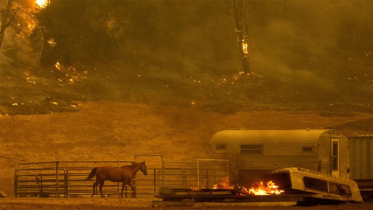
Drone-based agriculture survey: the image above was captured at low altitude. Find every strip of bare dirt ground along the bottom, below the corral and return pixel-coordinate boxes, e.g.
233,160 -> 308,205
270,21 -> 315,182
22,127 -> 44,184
0,198 -> 373,210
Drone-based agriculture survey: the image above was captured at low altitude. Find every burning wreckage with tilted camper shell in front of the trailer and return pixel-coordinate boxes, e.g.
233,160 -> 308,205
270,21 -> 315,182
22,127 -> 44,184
156,168 -> 363,204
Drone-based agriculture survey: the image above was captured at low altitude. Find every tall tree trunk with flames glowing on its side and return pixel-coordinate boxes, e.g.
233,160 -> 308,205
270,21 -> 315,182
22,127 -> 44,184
233,0 -> 250,72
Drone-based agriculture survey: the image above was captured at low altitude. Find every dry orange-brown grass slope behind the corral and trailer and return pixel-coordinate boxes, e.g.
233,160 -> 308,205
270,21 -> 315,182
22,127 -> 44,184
0,102 -> 373,196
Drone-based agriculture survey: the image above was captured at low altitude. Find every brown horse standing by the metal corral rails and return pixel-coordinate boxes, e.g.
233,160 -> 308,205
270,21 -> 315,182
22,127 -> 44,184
87,161 -> 148,198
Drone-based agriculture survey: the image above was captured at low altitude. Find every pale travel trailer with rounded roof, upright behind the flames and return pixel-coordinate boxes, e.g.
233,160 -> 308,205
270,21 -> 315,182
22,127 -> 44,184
208,129 -> 350,186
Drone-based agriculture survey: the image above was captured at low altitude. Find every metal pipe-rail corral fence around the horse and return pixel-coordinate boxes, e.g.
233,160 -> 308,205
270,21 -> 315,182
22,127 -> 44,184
14,157 -> 228,197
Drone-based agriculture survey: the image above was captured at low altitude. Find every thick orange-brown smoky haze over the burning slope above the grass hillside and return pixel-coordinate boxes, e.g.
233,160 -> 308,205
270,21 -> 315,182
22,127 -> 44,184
0,0 -> 373,113
